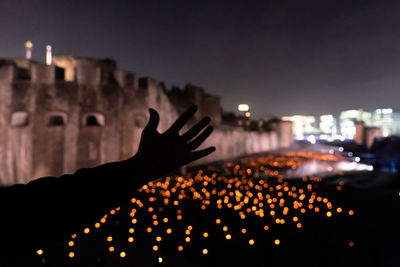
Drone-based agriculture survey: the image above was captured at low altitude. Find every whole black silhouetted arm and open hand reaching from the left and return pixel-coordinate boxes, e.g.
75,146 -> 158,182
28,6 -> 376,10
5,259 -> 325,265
0,106 -> 215,263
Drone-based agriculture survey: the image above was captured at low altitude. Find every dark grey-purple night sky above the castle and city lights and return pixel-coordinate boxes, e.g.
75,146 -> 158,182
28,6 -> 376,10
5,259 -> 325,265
0,0 -> 400,118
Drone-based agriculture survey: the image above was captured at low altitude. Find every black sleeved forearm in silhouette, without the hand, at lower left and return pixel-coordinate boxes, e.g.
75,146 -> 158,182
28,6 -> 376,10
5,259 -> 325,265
0,161 -> 148,261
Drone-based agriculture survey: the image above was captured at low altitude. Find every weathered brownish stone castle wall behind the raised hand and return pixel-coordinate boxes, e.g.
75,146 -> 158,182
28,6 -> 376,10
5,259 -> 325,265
0,57 -> 288,185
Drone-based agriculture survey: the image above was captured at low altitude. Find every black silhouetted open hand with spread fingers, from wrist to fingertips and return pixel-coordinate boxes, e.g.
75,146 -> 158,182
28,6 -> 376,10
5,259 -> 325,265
132,106 -> 215,178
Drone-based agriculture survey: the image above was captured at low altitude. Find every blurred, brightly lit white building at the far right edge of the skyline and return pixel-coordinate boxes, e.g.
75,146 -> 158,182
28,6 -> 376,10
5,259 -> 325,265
371,108 -> 400,137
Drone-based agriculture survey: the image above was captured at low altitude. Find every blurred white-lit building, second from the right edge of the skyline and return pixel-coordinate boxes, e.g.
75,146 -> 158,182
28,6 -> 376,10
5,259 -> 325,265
340,109 -> 371,139
